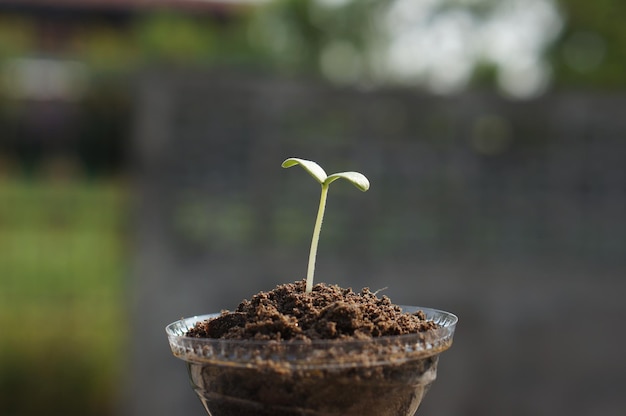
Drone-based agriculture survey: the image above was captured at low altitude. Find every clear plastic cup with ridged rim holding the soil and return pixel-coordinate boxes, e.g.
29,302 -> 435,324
166,306 -> 457,416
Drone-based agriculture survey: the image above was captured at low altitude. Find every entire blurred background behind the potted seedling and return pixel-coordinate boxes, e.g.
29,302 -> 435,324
0,0 -> 626,416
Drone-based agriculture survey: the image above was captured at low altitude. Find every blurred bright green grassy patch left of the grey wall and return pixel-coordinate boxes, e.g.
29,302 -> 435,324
0,178 -> 128,416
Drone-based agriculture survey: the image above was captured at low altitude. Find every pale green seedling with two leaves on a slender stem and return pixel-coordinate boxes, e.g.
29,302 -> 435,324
281,157 -> 370,293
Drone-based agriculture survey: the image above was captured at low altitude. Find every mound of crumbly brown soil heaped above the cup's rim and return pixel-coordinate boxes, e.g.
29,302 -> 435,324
187,281 -> 437,341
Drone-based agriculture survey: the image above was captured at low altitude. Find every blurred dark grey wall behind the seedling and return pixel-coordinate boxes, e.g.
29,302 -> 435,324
129,72 -> 626,415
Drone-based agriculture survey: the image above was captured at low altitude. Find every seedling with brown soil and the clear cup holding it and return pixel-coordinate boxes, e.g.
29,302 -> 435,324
166,158 -> 457,416
